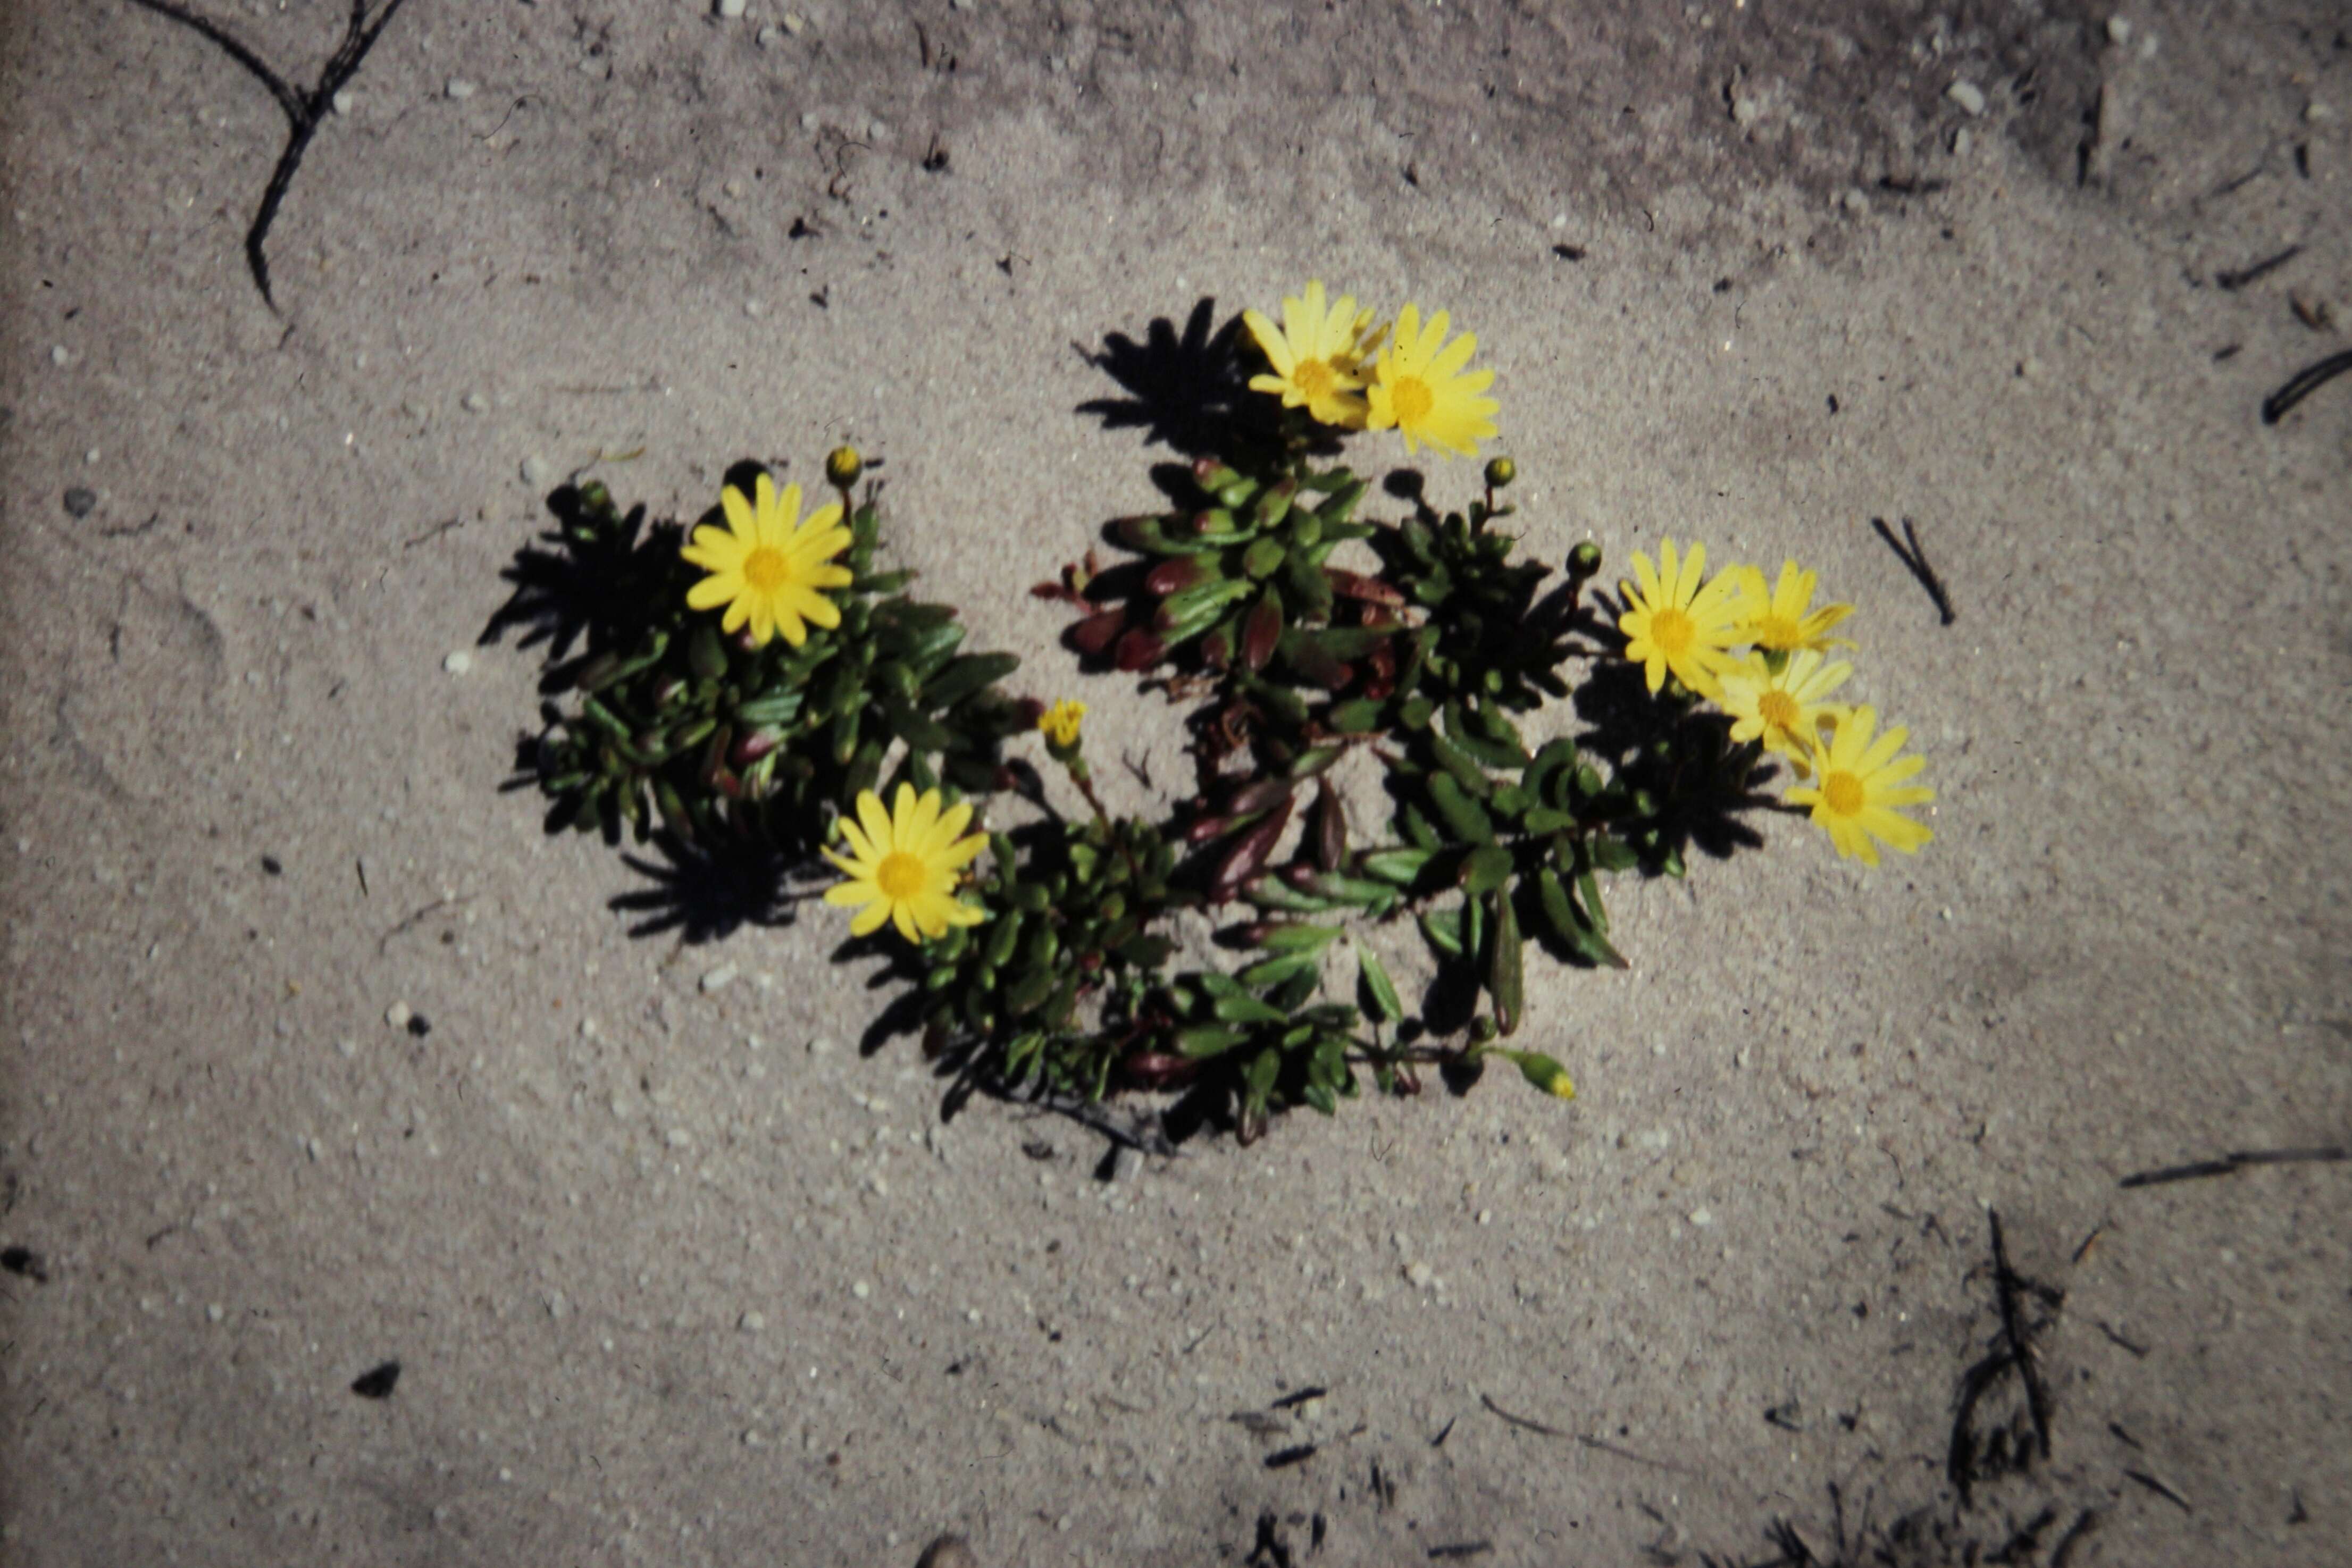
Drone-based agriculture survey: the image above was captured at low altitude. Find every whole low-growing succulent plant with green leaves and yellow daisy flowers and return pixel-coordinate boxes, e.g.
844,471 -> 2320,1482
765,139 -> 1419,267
505,284 -> 1931,1143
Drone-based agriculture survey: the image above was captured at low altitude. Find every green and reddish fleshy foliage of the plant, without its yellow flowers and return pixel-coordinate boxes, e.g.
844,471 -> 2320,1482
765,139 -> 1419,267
520,439 -> 1759,1140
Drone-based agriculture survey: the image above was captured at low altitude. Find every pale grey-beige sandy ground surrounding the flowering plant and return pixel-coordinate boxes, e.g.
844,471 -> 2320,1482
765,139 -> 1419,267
0,0 -> 2352,1568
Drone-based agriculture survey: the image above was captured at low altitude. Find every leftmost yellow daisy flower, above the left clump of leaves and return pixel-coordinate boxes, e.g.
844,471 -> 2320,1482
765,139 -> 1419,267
680,475 -> 849,649
